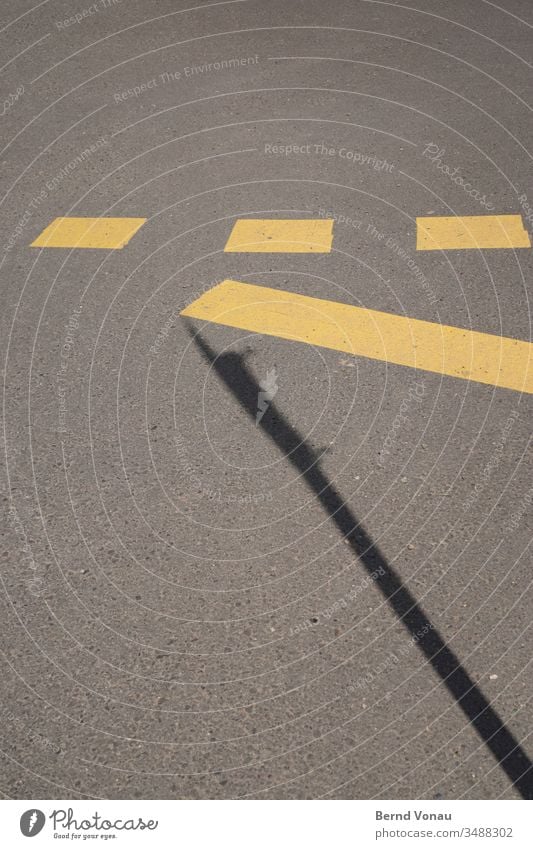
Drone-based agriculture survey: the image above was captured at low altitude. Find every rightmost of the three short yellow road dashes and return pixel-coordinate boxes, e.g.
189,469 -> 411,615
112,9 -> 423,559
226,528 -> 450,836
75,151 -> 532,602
416,215 -> 531,251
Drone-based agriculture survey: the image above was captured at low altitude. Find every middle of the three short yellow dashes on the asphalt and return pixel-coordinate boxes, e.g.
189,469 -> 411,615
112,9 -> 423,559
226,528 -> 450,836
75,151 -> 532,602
224,218 -> 333,254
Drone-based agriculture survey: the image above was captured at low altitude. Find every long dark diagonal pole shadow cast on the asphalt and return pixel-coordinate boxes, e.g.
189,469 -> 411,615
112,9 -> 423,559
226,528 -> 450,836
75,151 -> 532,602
184,319 -> 533,799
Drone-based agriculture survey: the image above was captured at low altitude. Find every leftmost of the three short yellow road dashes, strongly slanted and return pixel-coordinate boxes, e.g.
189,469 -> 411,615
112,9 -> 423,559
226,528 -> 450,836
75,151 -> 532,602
31,218 -> 146,250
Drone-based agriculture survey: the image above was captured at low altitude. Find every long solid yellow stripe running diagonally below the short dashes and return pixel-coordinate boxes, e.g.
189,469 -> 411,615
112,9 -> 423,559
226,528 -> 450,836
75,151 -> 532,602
181,280 -> 533,393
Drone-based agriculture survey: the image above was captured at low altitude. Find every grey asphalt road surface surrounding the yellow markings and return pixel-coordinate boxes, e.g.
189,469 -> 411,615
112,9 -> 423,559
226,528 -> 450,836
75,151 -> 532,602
0,0 -> 533,799
